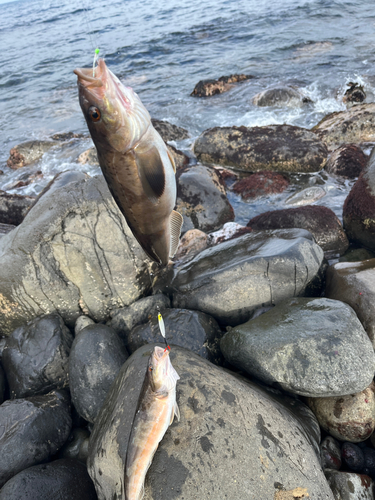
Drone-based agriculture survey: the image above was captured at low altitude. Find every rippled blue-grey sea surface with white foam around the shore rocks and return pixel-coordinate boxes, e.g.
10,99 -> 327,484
0,0 -> 375,223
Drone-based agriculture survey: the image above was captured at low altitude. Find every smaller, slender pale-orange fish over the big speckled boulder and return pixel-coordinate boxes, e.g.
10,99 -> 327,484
125,346 -> 180,500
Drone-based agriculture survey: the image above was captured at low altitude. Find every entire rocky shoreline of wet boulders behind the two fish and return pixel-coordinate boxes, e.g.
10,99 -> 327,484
0,94 -> 375,500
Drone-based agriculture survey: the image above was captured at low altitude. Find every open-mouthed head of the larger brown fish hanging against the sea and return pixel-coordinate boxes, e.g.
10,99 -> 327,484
74,59 -> 151,153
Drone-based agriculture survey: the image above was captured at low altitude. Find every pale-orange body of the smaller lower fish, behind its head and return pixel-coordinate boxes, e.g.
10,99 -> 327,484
125,395 -> 175,500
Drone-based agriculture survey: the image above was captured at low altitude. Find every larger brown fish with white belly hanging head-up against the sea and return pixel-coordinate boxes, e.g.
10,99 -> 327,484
74,59 -> 183,265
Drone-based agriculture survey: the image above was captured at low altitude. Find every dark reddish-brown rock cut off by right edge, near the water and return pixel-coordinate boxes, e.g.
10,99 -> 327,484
343,147 -> 375,250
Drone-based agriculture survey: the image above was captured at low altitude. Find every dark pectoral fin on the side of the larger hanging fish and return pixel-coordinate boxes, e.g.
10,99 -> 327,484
133,146 -> 165,203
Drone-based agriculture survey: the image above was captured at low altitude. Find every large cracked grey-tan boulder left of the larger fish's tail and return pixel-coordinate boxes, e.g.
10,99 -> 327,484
0,176 -> 150,335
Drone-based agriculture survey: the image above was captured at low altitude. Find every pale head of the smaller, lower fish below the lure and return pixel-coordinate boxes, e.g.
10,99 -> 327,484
148,346 -> 180,392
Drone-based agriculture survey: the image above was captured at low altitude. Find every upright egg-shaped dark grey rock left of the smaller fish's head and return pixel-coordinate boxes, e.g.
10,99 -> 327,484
69,324 -> 128,423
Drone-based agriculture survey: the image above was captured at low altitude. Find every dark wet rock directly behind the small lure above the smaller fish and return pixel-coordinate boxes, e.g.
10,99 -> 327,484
126,309 -> 223,364
